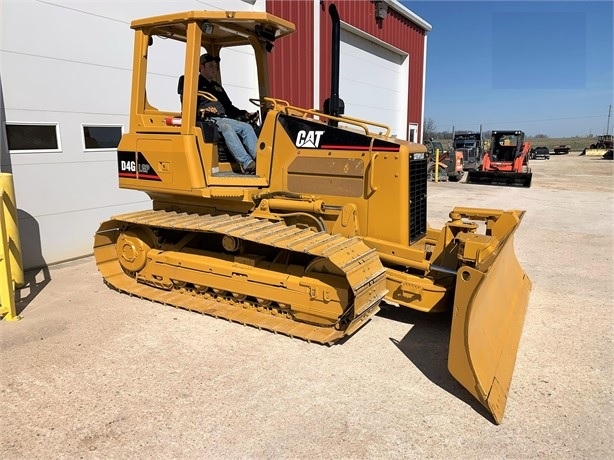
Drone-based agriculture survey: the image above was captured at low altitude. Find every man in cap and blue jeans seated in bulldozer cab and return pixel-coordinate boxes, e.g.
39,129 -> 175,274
178,53 -> 258,174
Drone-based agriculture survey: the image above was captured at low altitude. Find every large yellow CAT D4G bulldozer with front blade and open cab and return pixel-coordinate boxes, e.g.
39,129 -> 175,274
94,5 -> 531,423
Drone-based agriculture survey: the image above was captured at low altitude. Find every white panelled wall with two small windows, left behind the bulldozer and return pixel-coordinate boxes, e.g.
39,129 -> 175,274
0,0 -> 265,268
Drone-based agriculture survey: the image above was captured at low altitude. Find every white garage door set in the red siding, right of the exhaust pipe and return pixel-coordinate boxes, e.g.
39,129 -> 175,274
339,25 -> 409,139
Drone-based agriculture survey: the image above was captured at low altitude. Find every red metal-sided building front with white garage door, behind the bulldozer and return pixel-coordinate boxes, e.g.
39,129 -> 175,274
266,0 -> 431,141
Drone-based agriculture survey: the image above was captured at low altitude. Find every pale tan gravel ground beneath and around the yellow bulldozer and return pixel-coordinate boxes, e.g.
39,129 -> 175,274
0,152 -> 614,459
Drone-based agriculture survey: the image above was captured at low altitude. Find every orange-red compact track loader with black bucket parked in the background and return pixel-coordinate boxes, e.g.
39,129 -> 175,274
467,131 -> 533,187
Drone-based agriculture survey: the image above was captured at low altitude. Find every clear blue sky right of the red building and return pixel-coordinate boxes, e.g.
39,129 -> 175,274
400,0 -> 614,137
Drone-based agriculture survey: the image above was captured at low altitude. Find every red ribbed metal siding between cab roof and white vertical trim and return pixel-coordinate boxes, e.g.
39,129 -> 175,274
266,0 -> 313,107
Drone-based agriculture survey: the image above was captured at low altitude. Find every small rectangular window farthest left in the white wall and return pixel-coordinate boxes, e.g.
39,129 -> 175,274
6,122 -> 62,153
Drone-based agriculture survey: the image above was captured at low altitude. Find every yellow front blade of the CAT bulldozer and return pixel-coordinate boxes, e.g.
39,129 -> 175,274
448,214 -> 532,424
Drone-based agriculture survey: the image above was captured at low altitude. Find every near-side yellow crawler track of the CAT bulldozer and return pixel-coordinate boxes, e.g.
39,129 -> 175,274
94,210 -> 387,344
